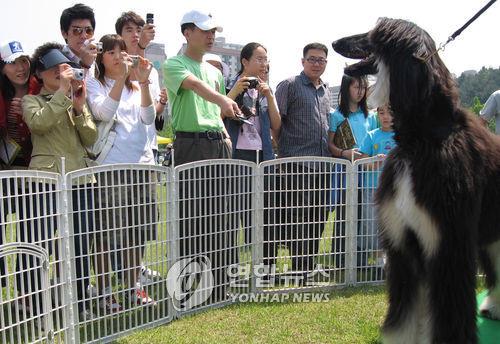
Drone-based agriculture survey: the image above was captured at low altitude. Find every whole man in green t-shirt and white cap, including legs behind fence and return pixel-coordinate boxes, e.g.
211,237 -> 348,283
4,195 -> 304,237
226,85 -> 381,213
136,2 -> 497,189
163,11 -> 240,310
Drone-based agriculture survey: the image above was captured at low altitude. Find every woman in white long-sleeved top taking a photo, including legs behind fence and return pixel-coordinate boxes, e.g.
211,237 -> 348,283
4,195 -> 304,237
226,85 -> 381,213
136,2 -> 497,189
87,35 -> 156,313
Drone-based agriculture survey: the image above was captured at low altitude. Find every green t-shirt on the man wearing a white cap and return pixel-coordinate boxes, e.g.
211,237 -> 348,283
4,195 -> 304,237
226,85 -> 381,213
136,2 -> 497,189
163,55 -> 226,132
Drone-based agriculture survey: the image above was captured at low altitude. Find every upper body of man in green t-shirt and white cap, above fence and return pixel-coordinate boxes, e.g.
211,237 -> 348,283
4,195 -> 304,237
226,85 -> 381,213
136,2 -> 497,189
163,11 -> 236,165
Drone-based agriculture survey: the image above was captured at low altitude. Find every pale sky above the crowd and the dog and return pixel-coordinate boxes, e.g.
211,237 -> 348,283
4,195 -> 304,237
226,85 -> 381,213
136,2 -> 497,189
0,0 -> 500,86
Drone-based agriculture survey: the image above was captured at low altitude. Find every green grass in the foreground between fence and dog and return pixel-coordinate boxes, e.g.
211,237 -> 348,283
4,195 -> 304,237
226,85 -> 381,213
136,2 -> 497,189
117,287 -> 386,344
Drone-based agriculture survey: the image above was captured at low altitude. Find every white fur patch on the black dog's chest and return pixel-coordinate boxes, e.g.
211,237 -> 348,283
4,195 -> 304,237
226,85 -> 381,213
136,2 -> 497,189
379,166 -> 441,258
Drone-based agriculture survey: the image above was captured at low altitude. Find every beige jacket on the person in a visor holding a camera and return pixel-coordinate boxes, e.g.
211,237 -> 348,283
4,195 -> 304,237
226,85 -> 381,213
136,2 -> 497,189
23,88 -> 97,173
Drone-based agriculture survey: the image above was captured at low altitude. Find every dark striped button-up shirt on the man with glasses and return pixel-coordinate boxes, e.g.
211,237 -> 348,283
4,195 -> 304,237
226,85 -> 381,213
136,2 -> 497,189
276,72 -> 331,158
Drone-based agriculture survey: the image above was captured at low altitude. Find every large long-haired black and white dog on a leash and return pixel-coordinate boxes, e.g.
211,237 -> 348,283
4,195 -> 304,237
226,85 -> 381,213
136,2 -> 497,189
332,18 -> 500,344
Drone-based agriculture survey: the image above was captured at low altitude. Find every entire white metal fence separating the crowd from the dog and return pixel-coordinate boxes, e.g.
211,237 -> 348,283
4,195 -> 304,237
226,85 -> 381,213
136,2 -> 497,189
0,157 -> 384,343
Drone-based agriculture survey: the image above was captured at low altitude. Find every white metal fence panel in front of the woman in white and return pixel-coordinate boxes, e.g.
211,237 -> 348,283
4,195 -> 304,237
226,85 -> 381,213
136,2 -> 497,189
65,164 -> 173,343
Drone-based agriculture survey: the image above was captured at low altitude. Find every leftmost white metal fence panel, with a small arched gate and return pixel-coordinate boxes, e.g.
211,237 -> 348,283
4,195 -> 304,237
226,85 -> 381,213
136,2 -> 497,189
0,171 -> 66,343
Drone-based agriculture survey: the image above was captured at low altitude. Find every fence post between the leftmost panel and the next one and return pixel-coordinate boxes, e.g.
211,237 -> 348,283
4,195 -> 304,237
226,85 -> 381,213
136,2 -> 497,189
59,157 -> 80,344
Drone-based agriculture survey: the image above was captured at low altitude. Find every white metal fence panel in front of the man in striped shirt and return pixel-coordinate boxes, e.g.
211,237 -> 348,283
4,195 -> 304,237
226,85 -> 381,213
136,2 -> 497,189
257,157 -> 349,291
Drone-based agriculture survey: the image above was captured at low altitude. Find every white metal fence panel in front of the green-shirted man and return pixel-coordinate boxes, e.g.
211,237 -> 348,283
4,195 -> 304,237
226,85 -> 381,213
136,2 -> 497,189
174,159 -> 257,315
